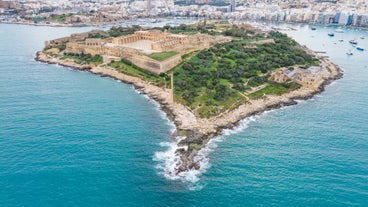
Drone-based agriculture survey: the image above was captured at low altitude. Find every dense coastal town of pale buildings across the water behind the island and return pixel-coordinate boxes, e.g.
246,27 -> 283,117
0,0 -> 368,27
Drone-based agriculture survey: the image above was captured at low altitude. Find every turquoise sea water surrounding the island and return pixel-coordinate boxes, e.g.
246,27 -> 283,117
0,24 -> 368,207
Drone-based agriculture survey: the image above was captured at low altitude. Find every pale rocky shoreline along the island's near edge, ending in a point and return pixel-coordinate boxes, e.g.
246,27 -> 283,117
35,51 -> 343,175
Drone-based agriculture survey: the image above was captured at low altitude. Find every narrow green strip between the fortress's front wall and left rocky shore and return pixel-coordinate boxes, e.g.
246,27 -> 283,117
108,59 -> 170,88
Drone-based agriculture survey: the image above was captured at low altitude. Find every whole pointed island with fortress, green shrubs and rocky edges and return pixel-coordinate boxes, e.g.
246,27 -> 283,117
36,21 -> 343,175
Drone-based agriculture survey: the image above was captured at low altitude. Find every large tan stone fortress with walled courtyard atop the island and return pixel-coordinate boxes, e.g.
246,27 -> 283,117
46,30 -> 231,74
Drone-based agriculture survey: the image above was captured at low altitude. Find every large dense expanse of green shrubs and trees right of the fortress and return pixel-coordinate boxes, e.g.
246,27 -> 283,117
174,28 -> 315,117
